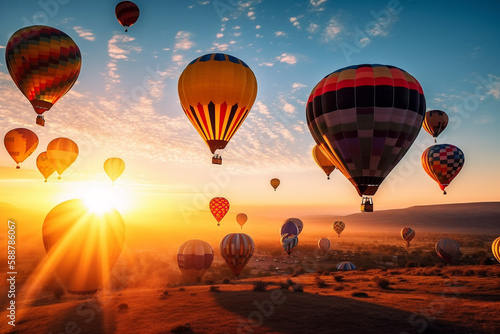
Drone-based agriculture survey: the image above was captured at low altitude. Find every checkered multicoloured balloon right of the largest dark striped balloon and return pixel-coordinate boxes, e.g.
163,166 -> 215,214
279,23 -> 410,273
421,144 -> 465,195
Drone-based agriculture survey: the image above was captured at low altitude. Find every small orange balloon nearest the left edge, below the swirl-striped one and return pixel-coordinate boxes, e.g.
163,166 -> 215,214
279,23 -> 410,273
3,128 -> 38,169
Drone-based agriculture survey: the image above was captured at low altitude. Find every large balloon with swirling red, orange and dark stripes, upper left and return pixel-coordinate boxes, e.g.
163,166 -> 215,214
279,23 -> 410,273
5,25 -> 82,126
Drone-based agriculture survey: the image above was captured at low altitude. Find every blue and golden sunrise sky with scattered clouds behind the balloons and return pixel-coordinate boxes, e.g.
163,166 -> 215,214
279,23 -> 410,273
0,0 -> 500,240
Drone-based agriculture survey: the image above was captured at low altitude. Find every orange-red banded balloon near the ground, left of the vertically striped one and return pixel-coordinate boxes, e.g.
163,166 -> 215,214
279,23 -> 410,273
177,239 -> 214,282
